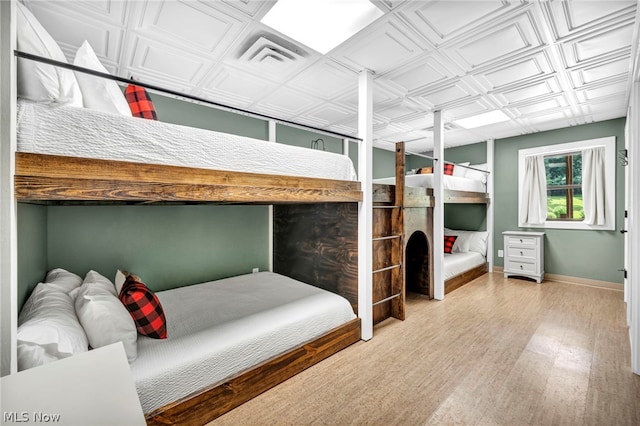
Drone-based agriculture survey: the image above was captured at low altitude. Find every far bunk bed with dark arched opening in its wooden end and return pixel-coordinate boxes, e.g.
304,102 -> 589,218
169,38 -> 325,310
374,142 -> 490,306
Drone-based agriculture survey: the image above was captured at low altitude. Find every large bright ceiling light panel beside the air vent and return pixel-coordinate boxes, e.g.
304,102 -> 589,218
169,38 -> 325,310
261,0 -> 383,55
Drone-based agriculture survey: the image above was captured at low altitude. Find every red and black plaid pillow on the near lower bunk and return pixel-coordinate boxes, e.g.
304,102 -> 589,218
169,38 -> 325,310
118,274 -> 167,339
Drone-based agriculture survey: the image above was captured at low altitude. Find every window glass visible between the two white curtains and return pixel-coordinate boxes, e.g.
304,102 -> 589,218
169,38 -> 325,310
544,152 -> 584,220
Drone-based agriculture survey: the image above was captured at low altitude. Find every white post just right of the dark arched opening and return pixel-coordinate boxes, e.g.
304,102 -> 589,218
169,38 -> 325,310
433,111 -> 444,300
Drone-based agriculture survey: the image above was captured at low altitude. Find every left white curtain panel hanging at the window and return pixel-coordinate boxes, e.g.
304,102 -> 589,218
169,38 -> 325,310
519,155 -> 547,225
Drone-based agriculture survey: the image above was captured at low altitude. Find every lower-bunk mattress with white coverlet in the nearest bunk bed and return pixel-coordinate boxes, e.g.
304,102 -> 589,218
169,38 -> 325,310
131,272 -> 356,413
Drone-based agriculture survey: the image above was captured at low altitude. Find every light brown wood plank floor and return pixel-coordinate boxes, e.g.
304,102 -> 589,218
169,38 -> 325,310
211,273 -> 640,425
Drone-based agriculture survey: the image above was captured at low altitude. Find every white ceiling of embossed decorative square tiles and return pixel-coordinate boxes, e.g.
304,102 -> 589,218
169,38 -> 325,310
25,0 -> 638,151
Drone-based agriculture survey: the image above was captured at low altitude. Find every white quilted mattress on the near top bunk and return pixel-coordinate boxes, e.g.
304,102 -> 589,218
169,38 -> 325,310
18,99 -> 357,180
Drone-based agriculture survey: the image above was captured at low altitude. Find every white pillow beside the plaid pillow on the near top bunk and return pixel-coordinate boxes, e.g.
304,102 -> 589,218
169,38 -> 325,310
73,40 -> 131,117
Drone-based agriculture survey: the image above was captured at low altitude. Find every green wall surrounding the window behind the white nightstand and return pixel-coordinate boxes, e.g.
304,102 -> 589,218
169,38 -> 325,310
493,118 -> 625,283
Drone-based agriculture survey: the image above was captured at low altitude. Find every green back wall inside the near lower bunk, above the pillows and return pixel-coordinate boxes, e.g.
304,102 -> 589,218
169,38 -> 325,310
47,205 -> 269,290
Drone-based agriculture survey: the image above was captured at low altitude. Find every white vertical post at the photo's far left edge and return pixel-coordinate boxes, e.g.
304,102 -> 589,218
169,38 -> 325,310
0,0 -> 18,376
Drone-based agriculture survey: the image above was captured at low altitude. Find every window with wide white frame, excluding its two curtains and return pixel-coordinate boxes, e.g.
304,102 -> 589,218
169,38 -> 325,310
518,136 -> 616,230
